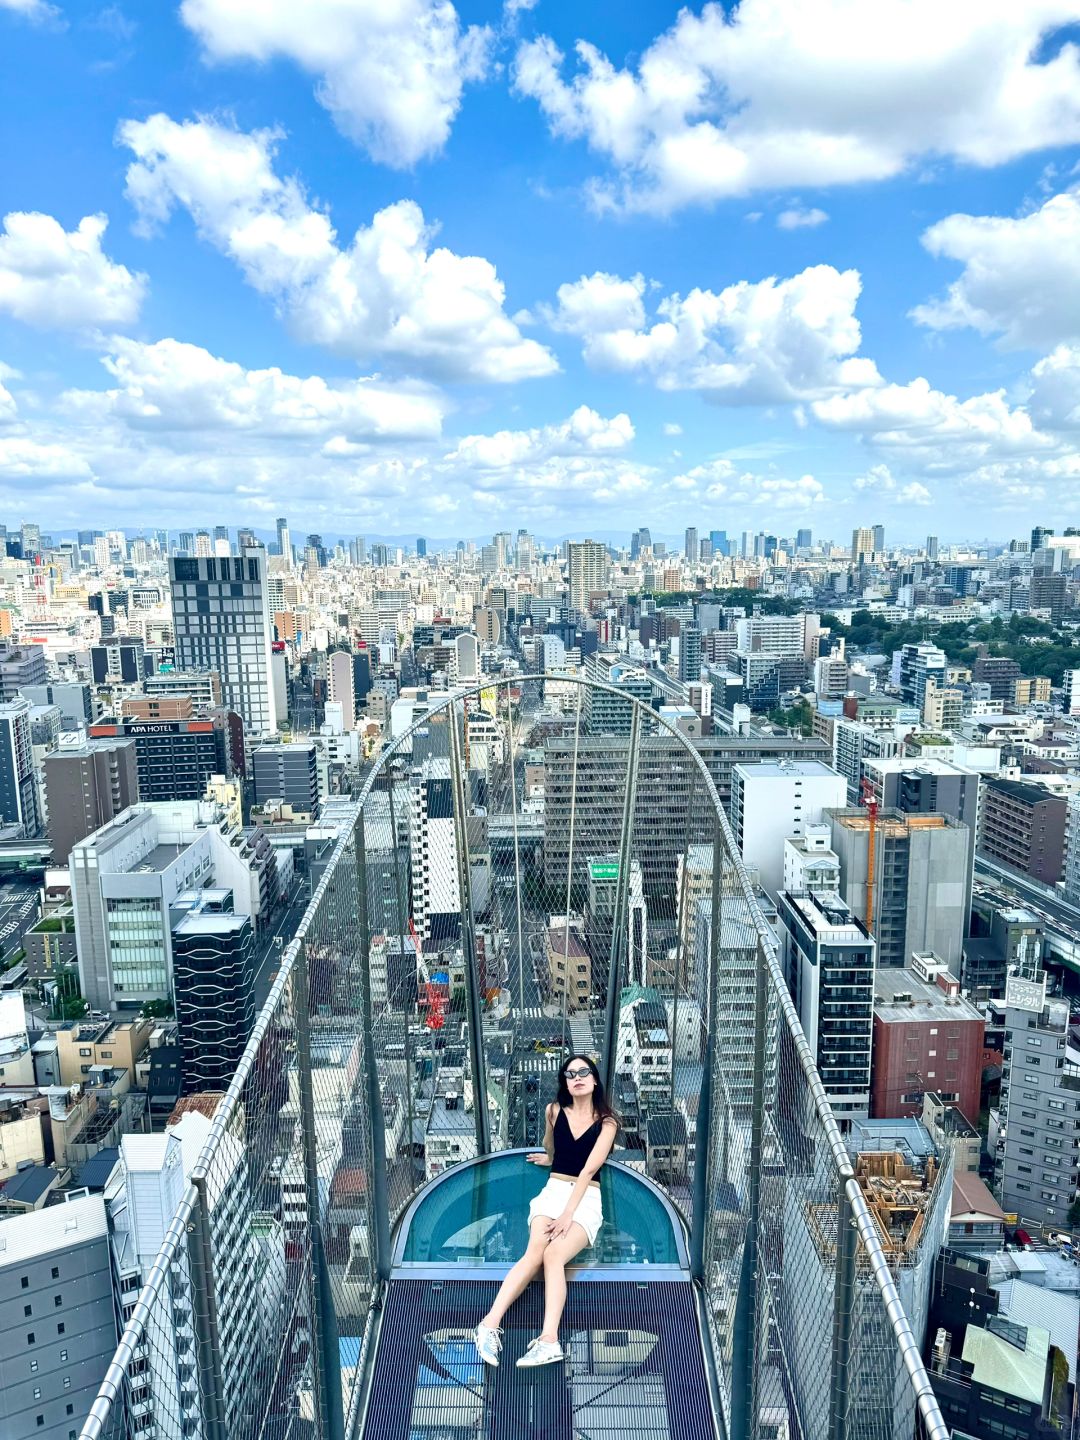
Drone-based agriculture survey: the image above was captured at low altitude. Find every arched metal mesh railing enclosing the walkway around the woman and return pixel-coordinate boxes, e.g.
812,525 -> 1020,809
82,675 -> 948,1440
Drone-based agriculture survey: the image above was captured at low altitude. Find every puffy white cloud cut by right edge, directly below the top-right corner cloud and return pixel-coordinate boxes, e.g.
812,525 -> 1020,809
912,190 -> 1080,348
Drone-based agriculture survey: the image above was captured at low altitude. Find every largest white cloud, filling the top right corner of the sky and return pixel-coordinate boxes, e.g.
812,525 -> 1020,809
514,0 -> 1080,212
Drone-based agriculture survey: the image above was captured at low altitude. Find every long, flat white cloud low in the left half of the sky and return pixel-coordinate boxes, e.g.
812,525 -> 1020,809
62,340 -> 444,444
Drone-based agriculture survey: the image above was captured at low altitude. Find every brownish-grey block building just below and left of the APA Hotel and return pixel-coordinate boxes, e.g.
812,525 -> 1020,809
43,739 -> 138,865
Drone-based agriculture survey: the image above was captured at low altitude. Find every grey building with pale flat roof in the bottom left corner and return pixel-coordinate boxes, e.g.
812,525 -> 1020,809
0,1195 -> 117,1440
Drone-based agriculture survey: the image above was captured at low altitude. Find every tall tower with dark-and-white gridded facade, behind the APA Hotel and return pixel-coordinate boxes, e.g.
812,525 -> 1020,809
168,550 -> 278,736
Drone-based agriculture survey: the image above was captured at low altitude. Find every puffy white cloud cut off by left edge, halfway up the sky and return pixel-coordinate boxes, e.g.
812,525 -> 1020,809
0,210 -> 147,330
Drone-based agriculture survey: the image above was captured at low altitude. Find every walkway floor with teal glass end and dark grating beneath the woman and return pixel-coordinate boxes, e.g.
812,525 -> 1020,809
363,1151 -> 717,1440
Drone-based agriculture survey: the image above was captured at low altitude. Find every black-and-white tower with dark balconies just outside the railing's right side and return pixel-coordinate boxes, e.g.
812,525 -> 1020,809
776,890 -> 876,1125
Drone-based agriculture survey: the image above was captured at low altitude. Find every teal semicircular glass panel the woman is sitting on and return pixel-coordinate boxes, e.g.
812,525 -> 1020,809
399,1152 -> 684,1266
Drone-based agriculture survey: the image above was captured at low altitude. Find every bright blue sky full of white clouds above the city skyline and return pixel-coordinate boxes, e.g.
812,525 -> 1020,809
0,0 -> 1080,541
